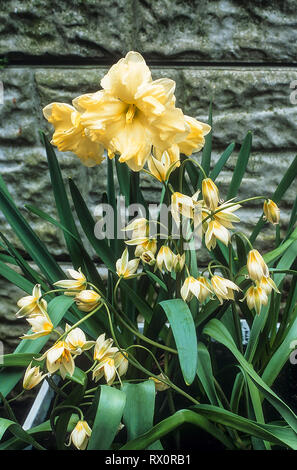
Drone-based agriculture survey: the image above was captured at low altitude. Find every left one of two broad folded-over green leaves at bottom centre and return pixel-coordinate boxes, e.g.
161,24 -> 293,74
88,385 -> 126,450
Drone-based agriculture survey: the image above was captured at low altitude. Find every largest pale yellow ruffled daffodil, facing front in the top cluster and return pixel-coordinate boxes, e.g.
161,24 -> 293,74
73,51 -> 190,171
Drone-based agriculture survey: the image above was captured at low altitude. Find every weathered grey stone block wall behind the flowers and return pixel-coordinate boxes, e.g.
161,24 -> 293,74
0,0 -> 297,346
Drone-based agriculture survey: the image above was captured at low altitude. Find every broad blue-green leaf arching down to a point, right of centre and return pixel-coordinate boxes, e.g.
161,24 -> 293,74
159,299 -> 197,385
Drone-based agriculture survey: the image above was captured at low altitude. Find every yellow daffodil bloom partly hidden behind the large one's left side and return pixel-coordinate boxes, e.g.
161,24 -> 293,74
43,103 -> 104,166
